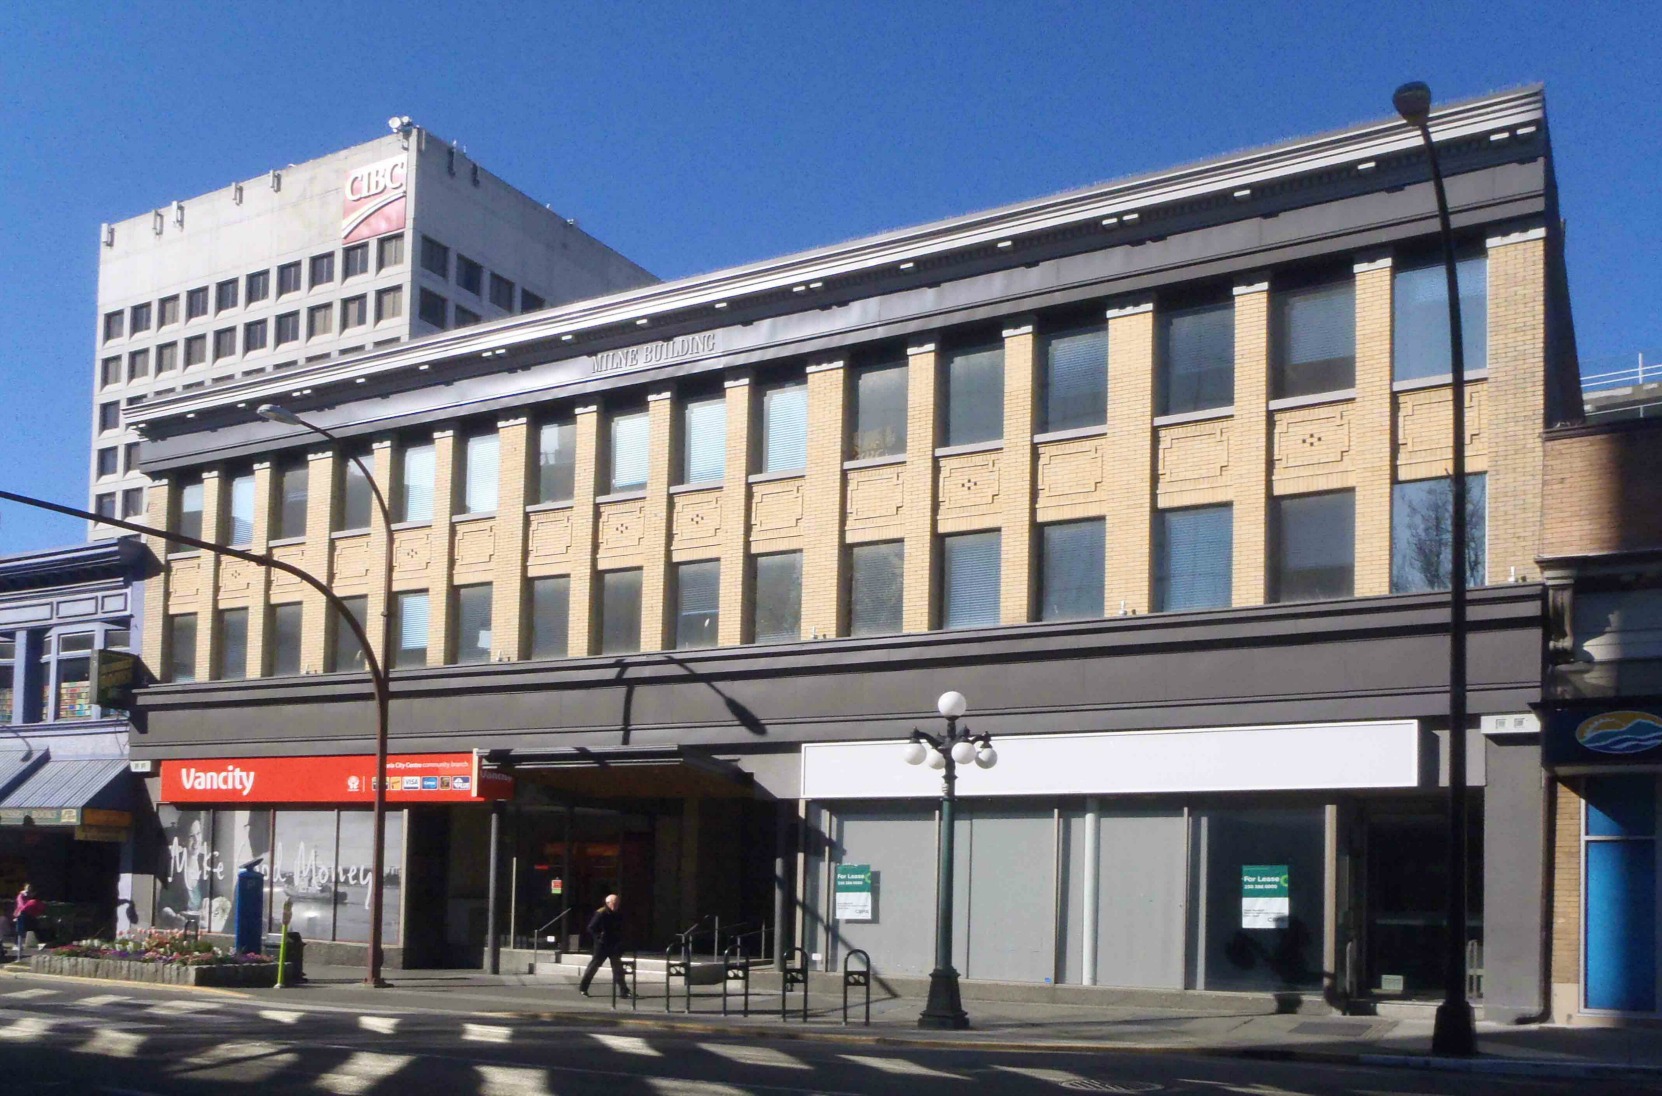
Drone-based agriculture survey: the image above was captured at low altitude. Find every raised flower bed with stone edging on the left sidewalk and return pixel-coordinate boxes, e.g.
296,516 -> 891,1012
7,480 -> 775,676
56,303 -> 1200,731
28,930 -> 293,988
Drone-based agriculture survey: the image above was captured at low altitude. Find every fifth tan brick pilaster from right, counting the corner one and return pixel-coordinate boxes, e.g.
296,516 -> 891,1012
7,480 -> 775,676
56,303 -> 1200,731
999,318 -> 1035,624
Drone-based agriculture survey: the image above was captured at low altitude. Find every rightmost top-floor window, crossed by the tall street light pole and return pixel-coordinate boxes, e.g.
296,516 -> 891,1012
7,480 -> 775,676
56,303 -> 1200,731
1391,256 -> 1489,381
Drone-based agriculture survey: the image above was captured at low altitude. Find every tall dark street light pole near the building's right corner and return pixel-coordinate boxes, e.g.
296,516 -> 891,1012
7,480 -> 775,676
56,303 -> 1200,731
1391,81 -> 1478,1054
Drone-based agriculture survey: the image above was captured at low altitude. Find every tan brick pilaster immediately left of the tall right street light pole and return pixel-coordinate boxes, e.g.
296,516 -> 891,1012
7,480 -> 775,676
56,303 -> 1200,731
1351,254 -> 1396,597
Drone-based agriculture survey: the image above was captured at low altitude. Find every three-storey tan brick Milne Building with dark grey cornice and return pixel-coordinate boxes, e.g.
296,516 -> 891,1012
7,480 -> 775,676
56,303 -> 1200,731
130,90 -> 1579,1016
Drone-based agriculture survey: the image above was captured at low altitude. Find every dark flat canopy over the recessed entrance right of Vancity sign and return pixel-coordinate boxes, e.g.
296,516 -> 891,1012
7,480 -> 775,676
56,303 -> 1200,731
484,745 -> 755,798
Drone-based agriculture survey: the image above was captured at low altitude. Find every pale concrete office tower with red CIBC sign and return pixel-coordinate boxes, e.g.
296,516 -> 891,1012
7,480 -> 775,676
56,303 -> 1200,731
88,120 -> 653,536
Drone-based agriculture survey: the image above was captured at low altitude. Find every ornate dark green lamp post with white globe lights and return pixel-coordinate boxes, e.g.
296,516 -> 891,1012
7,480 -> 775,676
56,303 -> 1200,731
901,692 -> 999,1029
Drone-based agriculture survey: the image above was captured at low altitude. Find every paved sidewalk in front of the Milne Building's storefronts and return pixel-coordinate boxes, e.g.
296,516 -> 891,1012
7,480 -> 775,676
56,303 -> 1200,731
242,966 -> 1662,1083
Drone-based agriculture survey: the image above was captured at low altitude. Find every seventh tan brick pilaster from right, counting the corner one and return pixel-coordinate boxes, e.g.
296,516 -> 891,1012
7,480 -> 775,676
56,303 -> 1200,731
803,361 -> 848,637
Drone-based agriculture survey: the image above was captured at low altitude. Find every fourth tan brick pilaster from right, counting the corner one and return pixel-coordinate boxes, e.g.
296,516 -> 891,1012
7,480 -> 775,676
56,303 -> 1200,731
1102,301 -> 1155,617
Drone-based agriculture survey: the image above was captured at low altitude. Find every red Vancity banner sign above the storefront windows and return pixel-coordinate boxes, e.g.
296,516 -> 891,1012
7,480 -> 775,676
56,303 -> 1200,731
161,753 -> 514,805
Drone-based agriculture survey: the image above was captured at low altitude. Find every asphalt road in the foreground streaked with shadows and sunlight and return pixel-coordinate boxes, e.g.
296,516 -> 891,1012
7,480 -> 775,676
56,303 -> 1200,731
0,978 -> 1662,1096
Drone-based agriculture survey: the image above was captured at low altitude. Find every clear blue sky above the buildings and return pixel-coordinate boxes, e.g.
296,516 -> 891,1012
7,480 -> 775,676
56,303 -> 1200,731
0,0 -> 1662,554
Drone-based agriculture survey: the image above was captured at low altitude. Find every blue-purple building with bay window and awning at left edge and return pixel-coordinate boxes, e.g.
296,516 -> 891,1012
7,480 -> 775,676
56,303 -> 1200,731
0,537 -> 144,943
